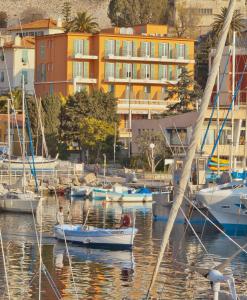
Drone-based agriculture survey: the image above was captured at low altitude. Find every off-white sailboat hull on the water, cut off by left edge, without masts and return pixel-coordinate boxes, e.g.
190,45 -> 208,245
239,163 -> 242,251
0,192 -> 40,213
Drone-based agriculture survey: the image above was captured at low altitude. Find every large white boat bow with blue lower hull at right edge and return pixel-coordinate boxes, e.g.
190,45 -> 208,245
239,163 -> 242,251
196,182 -> 247,230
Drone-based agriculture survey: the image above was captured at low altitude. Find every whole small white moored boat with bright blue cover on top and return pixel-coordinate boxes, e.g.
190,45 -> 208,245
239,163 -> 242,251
106,188 -> 153,202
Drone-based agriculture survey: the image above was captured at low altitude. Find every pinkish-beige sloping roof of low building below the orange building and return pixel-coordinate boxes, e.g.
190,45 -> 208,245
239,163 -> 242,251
132,111 -> 198,131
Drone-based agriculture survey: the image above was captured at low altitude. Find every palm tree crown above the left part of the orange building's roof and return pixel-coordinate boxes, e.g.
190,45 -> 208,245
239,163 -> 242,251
70,11 -> 99,33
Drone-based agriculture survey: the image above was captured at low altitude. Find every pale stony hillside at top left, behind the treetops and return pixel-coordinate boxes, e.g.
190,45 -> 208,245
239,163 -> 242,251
4,0 -> 110,28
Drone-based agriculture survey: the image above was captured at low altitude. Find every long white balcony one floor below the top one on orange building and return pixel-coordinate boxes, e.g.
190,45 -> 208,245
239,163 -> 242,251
105,76 -> 178,85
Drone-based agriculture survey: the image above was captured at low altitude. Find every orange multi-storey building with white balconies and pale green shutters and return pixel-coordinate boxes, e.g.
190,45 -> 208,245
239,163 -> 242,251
35,24 -> 195,138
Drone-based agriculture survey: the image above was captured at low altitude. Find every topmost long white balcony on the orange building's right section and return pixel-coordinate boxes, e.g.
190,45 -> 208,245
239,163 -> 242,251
105,50 -> 195,64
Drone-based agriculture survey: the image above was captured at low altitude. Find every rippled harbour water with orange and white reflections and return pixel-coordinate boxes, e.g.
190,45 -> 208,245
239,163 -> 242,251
0,198 -> 247,300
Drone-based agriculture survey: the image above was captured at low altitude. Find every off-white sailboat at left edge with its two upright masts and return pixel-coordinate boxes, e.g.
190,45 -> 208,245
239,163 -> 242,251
0,78 -> 41,213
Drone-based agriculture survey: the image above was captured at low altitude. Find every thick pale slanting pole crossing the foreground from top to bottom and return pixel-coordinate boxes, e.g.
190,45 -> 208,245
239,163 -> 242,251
146,0 -> 236,299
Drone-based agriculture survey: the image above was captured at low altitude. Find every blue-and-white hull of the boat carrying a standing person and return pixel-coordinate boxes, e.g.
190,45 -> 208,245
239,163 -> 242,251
55,224 -> 137,248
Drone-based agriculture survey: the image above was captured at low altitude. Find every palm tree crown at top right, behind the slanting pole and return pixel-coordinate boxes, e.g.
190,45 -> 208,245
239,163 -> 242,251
212,7 -> 245,44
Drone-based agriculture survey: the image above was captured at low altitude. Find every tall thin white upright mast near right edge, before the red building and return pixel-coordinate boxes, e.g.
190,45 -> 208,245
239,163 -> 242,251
230,31 -> 236,172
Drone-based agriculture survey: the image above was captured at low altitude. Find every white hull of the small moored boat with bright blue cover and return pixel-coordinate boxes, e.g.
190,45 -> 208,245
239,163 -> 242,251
106,192 -> 153,202
